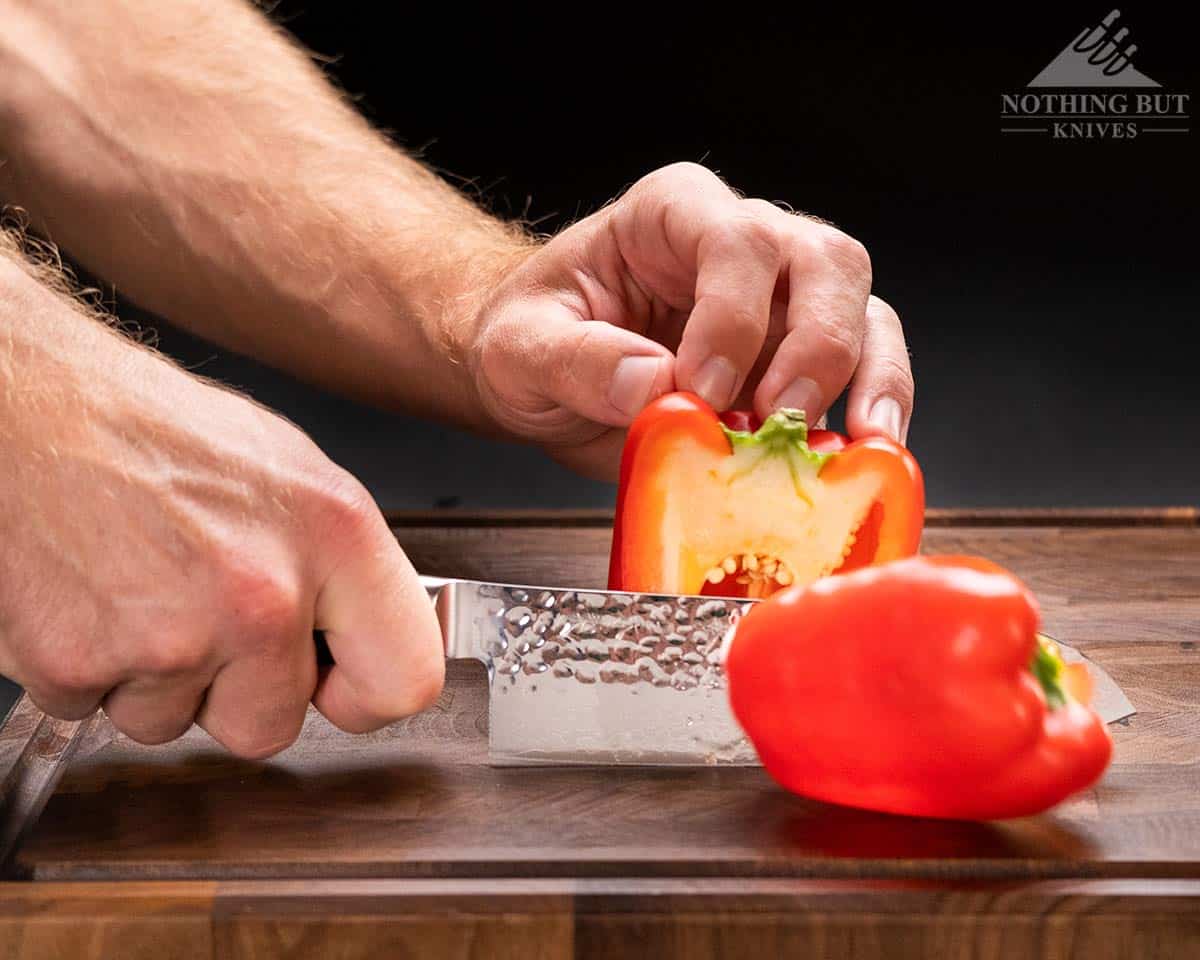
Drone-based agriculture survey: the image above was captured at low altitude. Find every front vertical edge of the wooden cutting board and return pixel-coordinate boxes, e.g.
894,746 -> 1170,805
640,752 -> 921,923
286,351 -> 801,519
0,878 -> 1200,960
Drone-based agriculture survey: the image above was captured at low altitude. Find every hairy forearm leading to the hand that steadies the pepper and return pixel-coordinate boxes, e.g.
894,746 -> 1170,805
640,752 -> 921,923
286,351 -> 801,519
0,0 -> 528,425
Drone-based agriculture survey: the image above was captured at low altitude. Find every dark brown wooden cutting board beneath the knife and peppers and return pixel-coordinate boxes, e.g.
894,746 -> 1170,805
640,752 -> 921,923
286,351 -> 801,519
0,509 -> 1200,960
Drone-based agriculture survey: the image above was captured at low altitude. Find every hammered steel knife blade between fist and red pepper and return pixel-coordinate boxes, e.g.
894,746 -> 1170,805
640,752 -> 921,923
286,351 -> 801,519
431,581 -> 757,766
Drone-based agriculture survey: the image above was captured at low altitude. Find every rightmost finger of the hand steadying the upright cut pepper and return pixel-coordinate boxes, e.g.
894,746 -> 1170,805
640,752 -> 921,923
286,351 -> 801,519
846,296 -> 913,443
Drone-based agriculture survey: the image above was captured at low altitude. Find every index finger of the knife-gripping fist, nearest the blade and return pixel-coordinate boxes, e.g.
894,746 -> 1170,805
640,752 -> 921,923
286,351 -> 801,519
313,499 -> 445,733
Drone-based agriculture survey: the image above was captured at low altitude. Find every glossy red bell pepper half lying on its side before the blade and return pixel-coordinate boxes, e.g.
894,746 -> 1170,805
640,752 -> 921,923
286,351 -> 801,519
725,557 -> 1112,820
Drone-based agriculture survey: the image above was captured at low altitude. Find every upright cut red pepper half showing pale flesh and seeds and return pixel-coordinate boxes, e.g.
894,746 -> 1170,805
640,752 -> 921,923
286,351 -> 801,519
608,392 -> 925,596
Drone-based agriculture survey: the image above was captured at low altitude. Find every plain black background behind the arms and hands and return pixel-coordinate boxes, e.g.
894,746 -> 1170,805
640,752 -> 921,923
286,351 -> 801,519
142,0 -> 1200,509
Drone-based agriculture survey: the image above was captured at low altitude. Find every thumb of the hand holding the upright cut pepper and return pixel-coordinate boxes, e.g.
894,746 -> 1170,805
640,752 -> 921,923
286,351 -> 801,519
480,298 -> 674,440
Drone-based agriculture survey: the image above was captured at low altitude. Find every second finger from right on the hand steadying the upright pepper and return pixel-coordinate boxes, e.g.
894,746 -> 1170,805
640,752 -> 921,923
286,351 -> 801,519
755,219 -> 871,422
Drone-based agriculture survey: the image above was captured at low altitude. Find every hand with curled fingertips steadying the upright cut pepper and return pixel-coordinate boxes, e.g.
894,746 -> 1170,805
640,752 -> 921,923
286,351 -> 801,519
464,163 -> 913,478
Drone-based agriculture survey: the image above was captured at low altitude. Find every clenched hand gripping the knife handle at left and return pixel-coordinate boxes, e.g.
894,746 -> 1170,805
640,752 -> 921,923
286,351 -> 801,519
0,243 -> 443,757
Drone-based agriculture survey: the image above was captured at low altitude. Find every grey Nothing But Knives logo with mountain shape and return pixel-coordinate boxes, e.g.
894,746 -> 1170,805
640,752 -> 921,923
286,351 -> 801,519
1000,10 -> 1192,140
